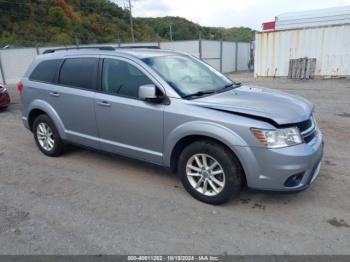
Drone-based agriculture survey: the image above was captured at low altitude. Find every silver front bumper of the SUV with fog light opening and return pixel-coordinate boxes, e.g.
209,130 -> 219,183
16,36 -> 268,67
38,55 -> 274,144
238,130 -> 324,192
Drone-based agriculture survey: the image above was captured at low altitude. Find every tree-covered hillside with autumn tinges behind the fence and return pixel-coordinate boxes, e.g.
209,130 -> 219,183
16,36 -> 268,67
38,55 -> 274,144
0,0 -> 253,46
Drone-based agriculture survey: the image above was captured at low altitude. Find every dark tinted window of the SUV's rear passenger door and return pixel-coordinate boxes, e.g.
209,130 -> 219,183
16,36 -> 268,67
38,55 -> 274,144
58,57 -> 98,89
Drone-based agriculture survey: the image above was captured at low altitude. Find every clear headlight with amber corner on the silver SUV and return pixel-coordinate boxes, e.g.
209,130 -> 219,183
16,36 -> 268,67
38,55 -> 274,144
250,127 -> 303,148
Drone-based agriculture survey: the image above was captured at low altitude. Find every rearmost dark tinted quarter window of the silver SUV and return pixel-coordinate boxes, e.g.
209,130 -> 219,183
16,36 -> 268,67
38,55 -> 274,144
29,59 -> 62,83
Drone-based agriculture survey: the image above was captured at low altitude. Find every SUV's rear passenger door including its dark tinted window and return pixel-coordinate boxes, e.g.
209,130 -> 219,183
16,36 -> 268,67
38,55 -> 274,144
49,56 -> 99,148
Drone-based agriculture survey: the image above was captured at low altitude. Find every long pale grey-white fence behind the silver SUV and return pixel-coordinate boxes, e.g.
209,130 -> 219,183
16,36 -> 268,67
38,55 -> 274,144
0,40 -> 251,84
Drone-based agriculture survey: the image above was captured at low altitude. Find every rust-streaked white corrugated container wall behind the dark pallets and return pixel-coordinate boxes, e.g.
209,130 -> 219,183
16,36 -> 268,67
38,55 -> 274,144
254,25 -> 350,77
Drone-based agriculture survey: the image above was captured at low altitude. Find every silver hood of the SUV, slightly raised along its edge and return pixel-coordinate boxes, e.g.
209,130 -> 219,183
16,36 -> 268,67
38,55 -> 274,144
190,86 -> 313,125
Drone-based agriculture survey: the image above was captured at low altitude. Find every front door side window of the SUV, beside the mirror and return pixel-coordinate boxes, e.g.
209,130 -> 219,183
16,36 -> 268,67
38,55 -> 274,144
102,58 -> 152,98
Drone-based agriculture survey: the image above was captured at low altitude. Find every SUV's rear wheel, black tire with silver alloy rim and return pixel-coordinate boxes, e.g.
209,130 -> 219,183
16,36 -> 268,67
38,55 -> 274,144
33,115 -> 64,157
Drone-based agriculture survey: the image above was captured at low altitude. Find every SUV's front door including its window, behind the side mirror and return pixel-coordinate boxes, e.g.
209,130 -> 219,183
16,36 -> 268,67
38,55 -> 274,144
95,58 -> 164,164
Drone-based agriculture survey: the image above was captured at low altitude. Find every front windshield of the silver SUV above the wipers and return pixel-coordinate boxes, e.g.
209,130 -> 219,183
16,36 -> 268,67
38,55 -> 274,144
143,55 -> 232,97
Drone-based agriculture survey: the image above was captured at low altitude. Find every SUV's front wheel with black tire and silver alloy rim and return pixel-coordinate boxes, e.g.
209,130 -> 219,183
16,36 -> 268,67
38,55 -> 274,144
178,140 -> 243,205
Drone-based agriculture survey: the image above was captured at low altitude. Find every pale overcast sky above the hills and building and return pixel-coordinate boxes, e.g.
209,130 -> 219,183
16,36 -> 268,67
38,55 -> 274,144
114,0 -> 350,30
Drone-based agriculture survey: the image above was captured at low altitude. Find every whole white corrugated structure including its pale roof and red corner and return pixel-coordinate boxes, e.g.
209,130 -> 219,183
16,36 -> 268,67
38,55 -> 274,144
254,6 -> 350,77
